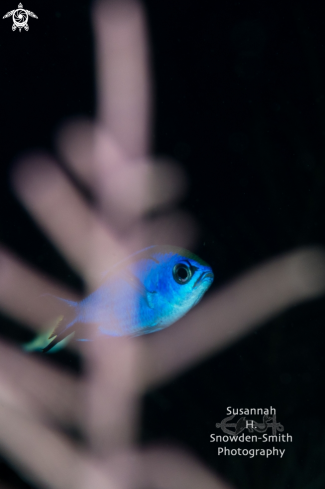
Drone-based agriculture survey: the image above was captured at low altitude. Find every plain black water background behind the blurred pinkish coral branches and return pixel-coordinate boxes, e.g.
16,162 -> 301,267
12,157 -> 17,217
0,0 -> 325,489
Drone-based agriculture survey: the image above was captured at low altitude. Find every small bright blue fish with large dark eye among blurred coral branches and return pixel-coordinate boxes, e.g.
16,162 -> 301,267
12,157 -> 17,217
25,245 -> 214,352
